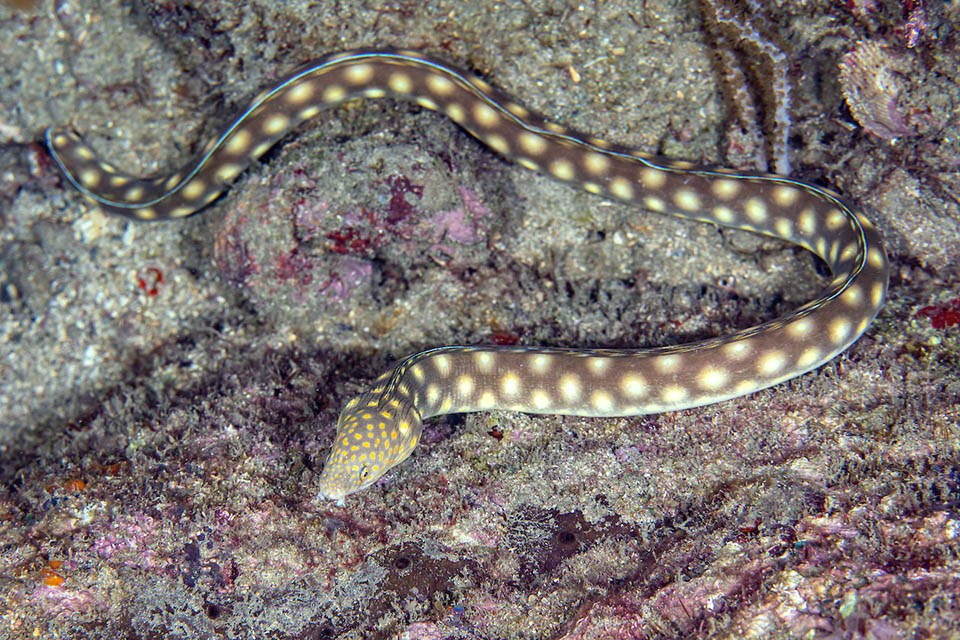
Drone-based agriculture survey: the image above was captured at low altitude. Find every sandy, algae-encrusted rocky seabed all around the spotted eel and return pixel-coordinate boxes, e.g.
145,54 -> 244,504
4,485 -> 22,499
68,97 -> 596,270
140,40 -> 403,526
0,0 -> 960,638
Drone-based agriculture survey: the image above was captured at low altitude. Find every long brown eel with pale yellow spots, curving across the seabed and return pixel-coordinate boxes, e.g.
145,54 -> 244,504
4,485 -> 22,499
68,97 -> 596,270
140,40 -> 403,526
46,50 -> 888,504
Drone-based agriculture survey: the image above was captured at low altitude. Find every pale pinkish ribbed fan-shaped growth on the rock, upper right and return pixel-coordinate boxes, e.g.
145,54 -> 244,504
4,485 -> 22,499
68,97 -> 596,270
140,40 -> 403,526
840,40 -> 917,140
